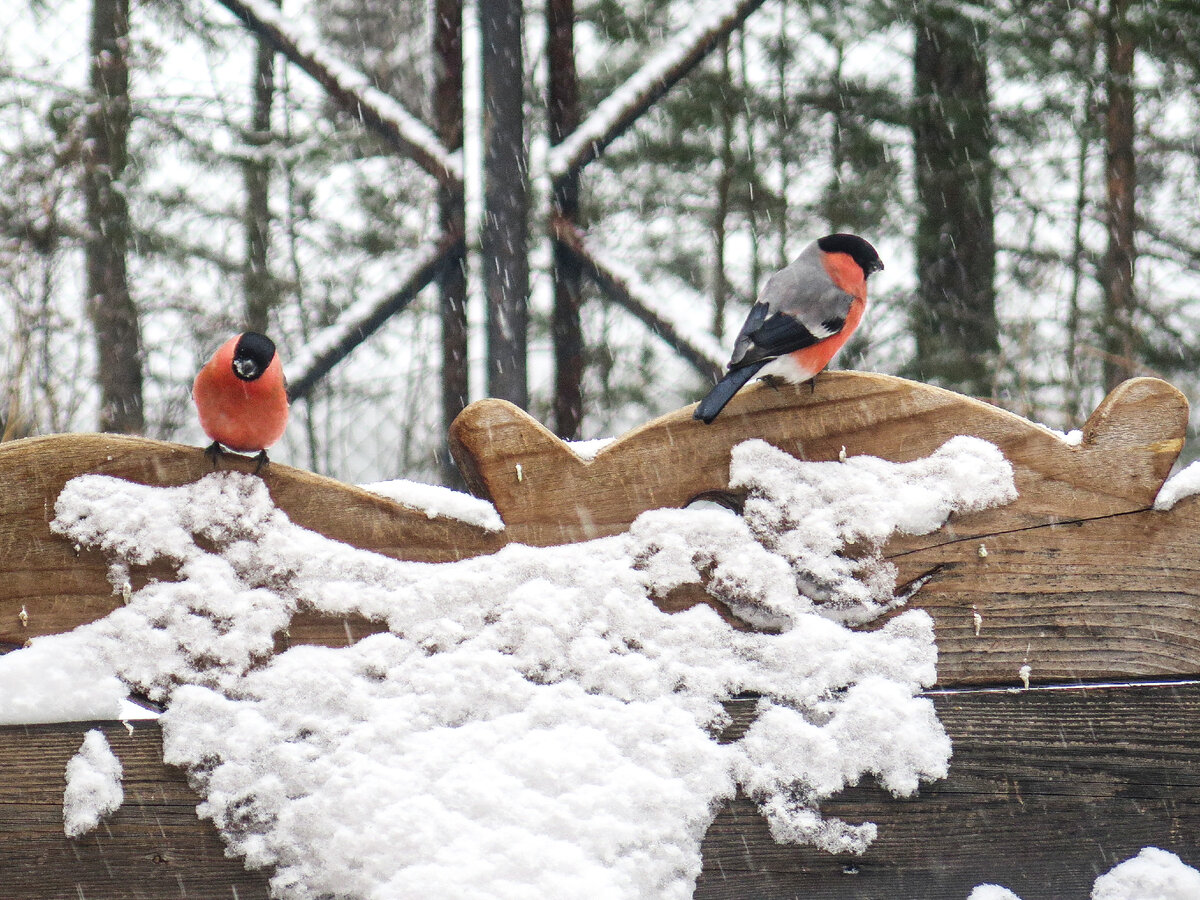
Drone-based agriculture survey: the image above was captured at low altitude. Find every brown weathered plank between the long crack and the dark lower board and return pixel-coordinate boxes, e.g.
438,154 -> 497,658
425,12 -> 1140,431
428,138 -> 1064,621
893,497 -> 1200,685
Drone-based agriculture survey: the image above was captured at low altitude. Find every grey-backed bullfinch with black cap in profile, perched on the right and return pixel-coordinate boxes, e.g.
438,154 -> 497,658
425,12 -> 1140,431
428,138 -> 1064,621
695,234 -> 883,425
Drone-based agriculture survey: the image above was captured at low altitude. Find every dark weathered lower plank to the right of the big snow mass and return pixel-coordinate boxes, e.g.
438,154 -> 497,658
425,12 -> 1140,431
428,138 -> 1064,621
695,684 -> 1200,900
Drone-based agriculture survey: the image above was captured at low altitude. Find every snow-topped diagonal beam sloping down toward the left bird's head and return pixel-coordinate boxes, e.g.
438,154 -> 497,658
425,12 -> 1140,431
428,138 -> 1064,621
286,234 -> 466,401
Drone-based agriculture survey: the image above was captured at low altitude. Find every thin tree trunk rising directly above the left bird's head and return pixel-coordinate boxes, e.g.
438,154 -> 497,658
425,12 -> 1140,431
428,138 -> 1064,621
242,0 -> 278,334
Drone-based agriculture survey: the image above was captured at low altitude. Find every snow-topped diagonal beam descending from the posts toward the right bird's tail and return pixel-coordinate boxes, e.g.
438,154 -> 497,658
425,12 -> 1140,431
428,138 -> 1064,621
550,215 -> 725,380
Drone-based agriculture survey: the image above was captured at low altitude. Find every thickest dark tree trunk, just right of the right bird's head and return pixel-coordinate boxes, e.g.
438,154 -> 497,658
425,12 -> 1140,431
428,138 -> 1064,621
910,2 -> 1000,396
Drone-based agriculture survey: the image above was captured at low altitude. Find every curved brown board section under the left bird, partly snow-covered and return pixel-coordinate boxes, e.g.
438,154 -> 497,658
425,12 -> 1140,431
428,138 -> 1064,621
0,434 -> 505,646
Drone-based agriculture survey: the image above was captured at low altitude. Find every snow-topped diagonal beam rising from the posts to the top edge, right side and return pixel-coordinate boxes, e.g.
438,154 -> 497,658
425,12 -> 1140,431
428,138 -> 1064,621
547,0 -> 763,181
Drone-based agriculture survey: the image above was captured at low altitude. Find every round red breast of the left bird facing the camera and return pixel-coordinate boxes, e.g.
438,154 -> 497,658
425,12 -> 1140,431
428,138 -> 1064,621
192,335 -> 288,454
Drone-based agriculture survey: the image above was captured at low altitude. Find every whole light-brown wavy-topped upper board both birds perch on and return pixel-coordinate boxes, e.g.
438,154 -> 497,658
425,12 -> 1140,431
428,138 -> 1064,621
0,372 -> 1200,685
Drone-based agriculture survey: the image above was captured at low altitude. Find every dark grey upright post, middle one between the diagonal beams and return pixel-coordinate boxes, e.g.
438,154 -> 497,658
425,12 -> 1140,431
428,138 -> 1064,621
479,0 -> 529,408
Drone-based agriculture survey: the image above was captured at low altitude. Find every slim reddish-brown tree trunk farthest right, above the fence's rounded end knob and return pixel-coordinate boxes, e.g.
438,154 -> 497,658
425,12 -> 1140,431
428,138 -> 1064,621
1103,0 -> 1138,390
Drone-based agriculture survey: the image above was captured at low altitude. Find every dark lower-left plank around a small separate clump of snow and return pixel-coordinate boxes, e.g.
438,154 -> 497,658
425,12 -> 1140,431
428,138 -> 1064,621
0,722 -> 269,900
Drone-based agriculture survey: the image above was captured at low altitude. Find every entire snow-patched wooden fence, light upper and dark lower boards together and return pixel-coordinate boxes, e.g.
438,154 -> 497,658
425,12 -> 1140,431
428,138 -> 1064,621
0,372 -> 1200,900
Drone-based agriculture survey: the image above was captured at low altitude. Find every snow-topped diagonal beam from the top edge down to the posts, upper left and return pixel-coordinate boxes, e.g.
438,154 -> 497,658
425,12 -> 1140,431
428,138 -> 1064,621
217,0 -> 462,188
